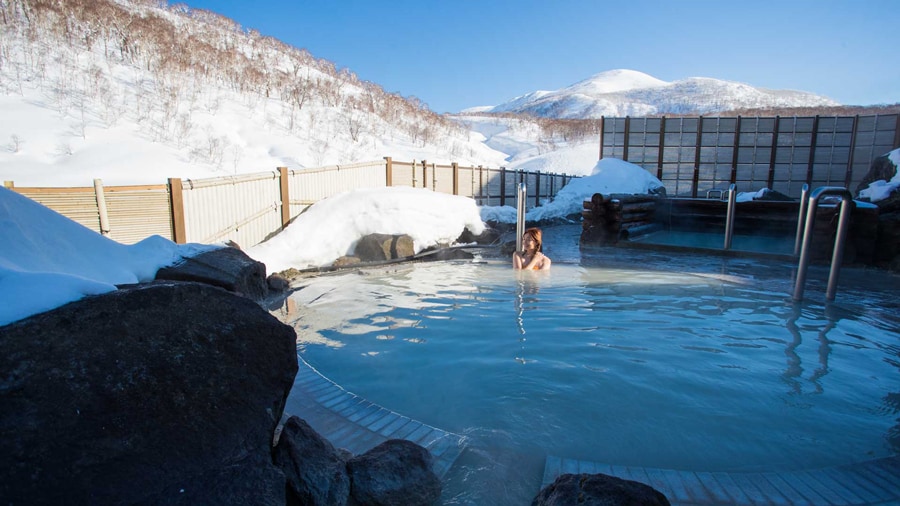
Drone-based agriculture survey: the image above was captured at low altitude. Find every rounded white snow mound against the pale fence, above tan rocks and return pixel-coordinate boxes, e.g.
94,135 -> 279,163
247,186 -> 486,272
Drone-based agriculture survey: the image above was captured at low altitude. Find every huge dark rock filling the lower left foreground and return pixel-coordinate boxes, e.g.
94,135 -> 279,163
0,282 -> 297,504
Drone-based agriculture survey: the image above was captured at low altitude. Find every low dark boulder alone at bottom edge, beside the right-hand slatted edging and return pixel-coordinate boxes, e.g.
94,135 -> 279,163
531,474 -> 669,506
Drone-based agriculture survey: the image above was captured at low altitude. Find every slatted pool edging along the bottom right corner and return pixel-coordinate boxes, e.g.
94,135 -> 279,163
541,457 -> 900,506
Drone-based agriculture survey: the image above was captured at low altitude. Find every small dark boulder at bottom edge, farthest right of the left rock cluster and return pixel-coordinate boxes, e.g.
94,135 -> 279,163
347,439 -> 441,506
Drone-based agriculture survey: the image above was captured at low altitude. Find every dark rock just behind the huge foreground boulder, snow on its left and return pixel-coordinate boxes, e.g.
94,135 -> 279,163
156,247 -> 269,301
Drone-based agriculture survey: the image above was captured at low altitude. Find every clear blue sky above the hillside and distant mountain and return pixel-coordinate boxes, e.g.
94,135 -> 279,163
178,0 -> 900,113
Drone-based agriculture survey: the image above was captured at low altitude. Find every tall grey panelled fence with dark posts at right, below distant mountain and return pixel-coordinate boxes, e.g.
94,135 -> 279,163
600,114 -> 900,198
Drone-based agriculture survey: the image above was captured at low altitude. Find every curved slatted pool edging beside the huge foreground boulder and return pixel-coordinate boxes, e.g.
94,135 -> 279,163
285,356 -> 465,477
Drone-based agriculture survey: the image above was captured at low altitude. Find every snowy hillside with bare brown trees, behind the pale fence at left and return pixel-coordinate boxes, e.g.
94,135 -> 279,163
0,0 -> 507,186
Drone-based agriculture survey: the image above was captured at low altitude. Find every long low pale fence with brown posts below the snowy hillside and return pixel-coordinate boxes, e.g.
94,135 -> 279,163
6,157 -> 572,247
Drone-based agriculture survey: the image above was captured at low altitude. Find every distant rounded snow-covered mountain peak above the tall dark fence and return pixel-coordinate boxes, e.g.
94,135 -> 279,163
482,69 -> 840,119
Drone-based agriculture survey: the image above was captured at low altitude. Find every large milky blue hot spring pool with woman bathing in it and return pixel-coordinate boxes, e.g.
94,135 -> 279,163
278,227 -> 900,504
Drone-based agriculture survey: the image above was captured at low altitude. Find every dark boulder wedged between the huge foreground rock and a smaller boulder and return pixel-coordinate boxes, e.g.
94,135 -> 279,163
274,416 -> 350,506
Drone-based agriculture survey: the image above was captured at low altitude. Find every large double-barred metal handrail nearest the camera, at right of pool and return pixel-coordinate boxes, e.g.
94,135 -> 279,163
794,186 -> 853,302
